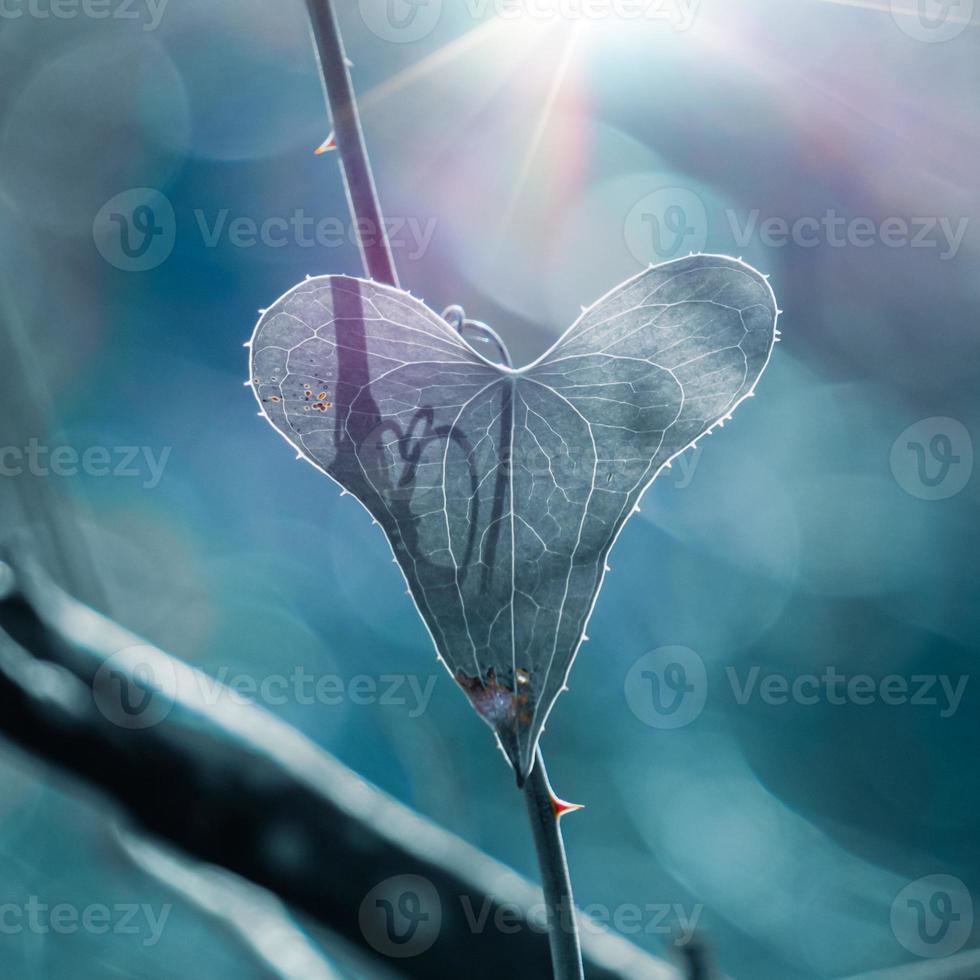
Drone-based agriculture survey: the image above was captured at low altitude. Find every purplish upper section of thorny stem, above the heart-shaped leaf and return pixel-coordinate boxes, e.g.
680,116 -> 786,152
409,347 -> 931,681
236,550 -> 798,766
307,0 -> 398,287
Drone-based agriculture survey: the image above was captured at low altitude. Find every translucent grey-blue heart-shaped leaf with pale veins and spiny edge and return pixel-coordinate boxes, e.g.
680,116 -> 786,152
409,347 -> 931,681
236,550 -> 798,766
251,255 -> 777,780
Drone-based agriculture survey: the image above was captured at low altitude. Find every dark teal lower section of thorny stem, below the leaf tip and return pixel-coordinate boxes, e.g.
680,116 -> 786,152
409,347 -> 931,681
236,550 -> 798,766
524,748 -> 585,980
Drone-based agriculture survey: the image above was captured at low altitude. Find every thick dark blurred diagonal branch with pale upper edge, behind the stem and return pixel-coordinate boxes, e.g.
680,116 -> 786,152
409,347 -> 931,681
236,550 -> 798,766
0,566 -> 678,980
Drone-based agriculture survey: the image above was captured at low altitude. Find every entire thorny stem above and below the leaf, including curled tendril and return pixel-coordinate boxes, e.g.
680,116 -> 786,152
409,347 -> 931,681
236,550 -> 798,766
307,0 -> 585,980
